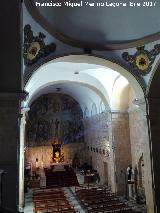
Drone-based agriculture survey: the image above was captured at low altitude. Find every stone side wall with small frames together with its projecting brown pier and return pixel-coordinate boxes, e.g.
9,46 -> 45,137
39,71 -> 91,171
84,112 -> 131,195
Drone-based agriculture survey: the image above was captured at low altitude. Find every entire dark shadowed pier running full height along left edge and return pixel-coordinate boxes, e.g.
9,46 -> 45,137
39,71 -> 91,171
0,0 -> 23,212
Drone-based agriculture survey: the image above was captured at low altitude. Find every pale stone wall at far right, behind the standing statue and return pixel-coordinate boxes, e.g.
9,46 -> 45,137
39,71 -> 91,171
129,104 -> 154,213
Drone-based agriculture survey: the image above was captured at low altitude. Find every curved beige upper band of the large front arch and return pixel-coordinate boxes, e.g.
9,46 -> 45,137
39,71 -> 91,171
25,54 -> 144,102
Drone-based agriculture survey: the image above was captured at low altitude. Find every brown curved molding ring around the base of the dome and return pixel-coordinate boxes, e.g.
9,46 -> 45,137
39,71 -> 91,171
24,0 -> 160,50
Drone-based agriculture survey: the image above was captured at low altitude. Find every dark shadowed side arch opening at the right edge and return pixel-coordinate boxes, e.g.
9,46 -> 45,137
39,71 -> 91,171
147,62 -> 160,213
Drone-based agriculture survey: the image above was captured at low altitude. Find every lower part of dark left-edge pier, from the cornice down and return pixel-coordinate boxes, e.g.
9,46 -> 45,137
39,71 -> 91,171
0,93 -> 24,212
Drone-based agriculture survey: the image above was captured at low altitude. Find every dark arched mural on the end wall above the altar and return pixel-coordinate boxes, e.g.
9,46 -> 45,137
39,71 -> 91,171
26,93 -> 84,146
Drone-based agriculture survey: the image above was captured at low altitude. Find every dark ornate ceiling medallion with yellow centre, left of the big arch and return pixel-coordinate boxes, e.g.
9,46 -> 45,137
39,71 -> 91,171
23,24 -> 56,66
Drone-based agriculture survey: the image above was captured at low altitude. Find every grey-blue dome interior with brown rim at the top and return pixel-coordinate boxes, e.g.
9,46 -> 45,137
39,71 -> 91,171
25,0 -> 160,49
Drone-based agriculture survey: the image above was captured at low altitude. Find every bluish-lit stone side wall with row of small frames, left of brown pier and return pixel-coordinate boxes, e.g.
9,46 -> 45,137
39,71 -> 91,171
84,112 -> 111,185
